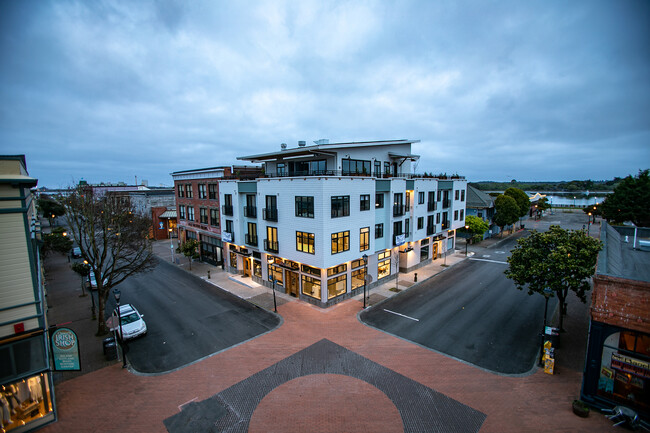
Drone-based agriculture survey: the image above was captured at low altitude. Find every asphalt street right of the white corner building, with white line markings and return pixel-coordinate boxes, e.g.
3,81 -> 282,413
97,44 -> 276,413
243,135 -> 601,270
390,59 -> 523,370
360,236 -> 556,374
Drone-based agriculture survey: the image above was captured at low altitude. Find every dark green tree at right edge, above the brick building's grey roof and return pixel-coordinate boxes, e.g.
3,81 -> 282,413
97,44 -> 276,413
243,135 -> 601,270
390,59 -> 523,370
602,169 -> 650,227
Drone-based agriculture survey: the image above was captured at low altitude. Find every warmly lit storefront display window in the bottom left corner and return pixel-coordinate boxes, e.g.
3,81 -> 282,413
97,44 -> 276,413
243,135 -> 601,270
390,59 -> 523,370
0,373 -> 54,432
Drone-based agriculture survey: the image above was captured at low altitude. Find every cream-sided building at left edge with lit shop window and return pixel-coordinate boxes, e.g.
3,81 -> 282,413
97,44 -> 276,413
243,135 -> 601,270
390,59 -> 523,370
0,155 -> 56,432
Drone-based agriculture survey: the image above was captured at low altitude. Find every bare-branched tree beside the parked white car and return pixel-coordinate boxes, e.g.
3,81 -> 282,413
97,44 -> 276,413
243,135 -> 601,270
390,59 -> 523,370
65,186 -> 156,335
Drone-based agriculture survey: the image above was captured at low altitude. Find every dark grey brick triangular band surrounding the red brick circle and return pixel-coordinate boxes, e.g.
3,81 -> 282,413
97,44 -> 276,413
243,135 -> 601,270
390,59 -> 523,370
165,339 -> 485,433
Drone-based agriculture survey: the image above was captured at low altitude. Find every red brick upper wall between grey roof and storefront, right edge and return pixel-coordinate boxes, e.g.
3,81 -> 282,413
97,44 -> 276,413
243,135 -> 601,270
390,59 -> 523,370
591,275 -> 650,333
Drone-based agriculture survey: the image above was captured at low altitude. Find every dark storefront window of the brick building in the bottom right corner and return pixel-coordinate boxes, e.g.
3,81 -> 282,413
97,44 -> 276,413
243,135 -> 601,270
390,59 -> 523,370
598,331 -> 650,410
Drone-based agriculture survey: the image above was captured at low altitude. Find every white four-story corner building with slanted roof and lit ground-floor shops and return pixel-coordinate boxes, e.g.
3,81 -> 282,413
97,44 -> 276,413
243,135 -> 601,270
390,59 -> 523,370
219,140 -> 467,307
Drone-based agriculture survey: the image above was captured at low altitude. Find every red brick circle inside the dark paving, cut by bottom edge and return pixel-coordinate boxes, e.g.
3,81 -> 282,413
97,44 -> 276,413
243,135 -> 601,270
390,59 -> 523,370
248,374 -> 404,433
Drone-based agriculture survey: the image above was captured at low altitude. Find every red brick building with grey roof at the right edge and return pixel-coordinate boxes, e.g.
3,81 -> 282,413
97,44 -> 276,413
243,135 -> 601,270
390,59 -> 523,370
581,224 -> 650,419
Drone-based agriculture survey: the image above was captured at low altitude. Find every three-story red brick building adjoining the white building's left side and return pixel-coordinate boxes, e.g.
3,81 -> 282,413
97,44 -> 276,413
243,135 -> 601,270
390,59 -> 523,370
171,166 -> 261,265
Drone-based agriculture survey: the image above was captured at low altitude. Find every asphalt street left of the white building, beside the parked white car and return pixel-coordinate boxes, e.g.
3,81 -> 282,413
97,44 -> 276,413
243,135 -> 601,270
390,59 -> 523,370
106,260 -> 281,373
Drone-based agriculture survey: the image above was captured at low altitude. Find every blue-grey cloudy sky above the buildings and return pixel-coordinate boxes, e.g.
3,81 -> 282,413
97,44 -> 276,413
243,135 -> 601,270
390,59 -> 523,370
0,0 -> 650,188
